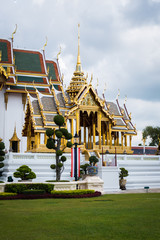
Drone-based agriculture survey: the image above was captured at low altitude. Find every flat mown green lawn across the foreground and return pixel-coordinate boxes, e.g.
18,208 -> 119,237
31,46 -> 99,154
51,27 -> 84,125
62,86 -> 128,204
0,193 -> 160,240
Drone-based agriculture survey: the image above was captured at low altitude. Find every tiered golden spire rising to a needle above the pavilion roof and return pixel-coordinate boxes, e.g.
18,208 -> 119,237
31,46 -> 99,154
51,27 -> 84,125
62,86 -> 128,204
67,24 -> 87,101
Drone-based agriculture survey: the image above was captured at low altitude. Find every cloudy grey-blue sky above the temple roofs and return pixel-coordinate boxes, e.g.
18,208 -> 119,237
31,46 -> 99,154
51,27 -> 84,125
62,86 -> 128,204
0,0 -> 160,144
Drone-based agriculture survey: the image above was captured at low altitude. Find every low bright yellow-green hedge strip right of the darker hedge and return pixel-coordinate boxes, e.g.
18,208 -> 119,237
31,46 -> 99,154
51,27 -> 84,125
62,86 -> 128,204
51,189 -> 95,195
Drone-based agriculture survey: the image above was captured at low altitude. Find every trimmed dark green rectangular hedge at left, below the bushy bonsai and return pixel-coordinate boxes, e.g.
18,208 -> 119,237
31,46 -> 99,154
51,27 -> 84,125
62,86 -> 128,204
5,183 -> 54,193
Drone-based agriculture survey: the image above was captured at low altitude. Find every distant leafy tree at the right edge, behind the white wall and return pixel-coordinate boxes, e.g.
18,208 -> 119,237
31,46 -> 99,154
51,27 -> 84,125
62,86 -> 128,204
142,126 -> 160,146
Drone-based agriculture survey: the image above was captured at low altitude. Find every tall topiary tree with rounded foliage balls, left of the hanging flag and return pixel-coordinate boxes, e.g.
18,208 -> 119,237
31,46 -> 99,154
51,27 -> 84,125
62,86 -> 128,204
46,115 -> 72,181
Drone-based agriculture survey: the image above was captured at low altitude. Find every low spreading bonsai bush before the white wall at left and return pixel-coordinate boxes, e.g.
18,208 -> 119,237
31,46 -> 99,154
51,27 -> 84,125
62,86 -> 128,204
13,165 -> 36,181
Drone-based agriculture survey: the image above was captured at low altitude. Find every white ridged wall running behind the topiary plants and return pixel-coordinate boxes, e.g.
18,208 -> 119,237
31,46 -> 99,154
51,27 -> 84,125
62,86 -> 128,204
1,153 -> 160,191
